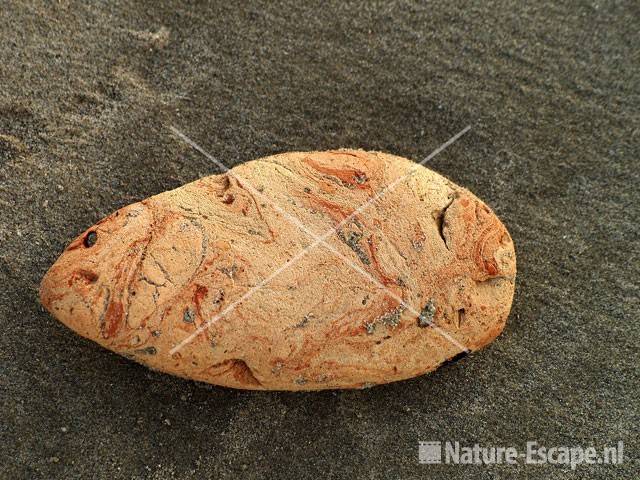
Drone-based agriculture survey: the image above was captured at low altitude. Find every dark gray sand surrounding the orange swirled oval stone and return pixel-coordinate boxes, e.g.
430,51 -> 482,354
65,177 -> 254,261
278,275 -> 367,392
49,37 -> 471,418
0,0 -> 640,479
